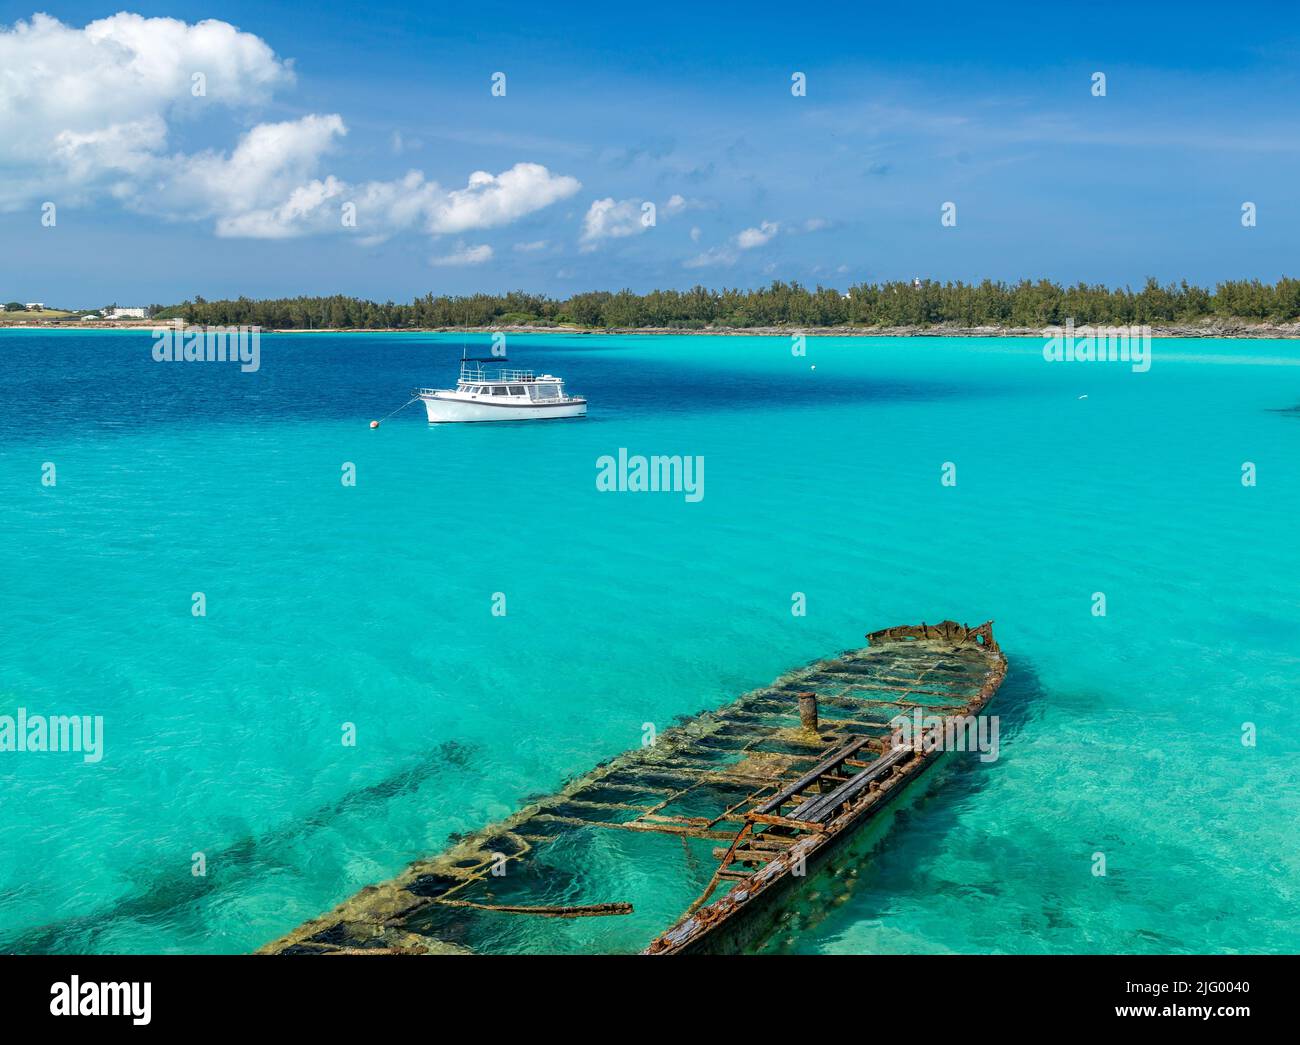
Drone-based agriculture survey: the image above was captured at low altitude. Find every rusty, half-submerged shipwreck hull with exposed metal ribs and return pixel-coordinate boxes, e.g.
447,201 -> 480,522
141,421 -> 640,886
261,621 -> 1006,954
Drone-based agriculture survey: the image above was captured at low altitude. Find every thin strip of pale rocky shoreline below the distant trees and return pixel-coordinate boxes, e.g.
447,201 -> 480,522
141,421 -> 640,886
0,320 -> 1300,341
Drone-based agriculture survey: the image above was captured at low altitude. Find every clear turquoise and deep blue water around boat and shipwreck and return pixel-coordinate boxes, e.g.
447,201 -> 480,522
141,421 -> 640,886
0,331 -> 1300,951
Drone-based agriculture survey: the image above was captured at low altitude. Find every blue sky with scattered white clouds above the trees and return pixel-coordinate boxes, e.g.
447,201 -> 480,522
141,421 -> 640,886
0,0 -> 1300,308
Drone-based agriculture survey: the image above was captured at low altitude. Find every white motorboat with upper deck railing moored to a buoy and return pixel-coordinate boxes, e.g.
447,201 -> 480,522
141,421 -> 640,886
412,359 -> 586,425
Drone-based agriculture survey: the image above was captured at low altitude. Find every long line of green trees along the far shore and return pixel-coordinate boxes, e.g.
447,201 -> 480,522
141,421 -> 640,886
153,278 -> 1300,330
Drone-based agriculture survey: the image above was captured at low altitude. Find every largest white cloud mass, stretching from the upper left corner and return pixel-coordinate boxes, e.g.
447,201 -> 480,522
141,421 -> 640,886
0,13 -> 581,244
